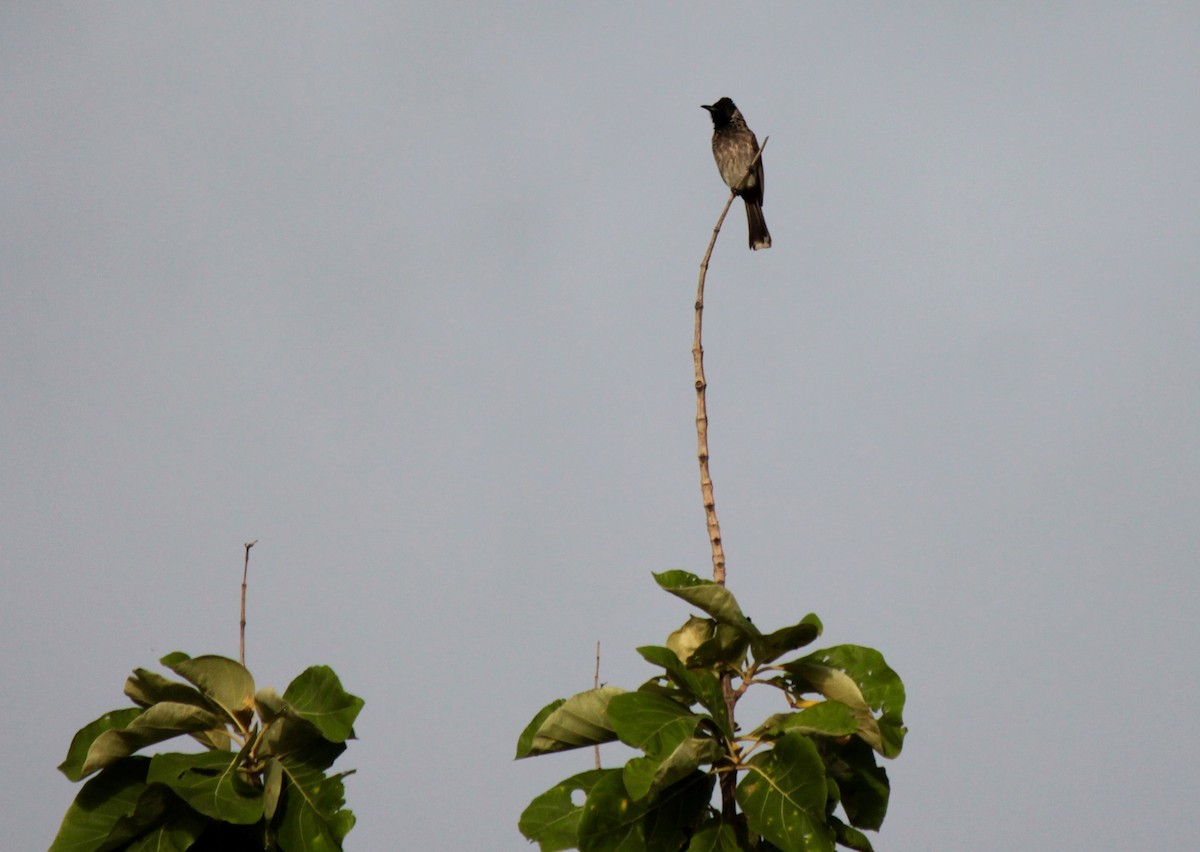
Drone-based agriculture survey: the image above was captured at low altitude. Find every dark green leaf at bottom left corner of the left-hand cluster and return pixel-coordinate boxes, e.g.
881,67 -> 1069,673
50,757 -> 150,852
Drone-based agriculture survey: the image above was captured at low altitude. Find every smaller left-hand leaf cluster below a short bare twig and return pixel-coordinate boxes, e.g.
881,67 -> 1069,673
50,652 -> 362,852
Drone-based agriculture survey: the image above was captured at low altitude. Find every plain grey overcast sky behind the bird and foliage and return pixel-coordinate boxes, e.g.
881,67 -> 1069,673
0,2 -> 1200,852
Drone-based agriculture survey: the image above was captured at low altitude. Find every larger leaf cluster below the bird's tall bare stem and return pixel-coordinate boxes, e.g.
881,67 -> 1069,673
516,571 -> 905,852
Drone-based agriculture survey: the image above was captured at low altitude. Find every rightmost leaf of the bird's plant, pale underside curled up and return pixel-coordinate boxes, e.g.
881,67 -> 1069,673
781,644 -> 906,757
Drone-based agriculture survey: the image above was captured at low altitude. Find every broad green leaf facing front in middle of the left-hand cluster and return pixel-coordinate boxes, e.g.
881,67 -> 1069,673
146,744 -> 263,826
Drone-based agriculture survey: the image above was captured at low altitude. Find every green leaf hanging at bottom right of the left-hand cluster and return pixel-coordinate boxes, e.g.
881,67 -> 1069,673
276,740 -> 354,852
